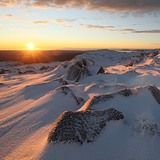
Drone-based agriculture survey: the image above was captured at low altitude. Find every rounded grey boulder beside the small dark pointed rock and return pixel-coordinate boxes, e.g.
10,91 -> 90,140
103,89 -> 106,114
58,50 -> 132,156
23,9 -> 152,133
67,59 -> 90,82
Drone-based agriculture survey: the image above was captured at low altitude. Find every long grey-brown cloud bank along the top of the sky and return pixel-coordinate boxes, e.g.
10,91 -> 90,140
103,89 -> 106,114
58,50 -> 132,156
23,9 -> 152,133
0,0 -> 160,12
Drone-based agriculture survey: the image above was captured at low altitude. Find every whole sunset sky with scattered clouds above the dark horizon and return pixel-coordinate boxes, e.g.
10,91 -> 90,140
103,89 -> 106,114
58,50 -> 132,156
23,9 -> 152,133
0,0 -> 160,50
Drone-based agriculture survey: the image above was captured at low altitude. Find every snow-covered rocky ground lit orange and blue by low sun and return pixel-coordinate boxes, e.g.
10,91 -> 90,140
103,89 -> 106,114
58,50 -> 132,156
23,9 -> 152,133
0,50 -> 160,160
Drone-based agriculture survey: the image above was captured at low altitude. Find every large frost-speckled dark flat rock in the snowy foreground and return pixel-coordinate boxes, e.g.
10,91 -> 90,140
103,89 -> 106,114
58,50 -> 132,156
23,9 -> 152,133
48,108 -> 124,144
